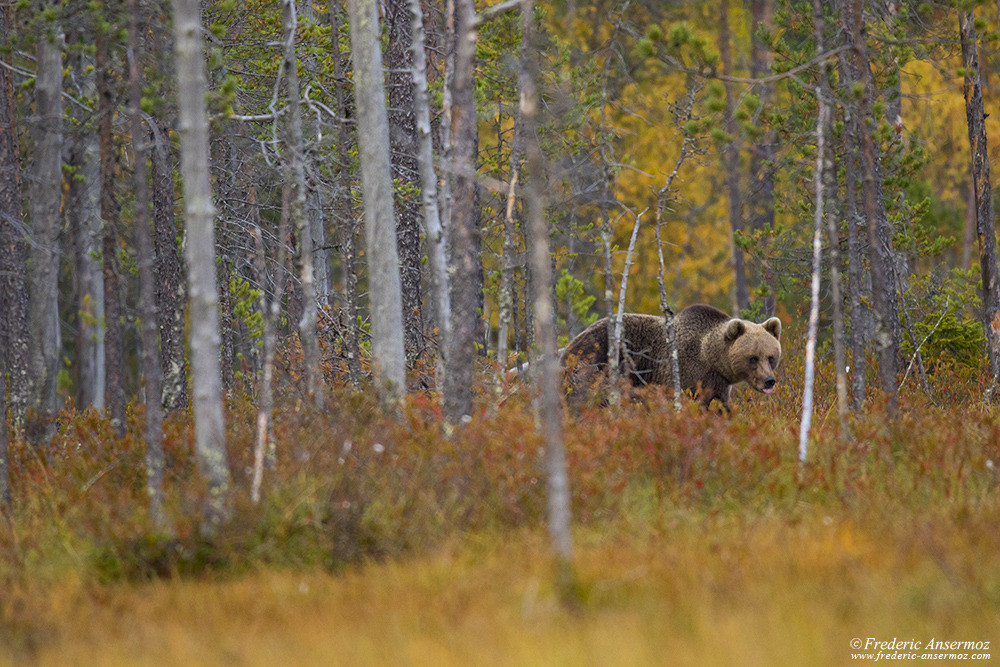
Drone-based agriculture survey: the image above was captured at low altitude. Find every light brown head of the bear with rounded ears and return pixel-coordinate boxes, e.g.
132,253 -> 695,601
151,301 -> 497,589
726,317 -> 781,394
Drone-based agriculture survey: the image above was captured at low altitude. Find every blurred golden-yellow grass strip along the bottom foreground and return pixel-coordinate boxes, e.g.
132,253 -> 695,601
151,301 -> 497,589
9,505 -> 1000,665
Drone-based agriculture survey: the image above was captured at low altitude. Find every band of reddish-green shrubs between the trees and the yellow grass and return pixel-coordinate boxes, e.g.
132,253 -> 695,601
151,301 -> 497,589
0,344 -> 1000,656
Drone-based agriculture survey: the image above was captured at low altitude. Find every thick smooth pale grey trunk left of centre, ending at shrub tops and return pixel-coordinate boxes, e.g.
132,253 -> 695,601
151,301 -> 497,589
347,0 -> 406,406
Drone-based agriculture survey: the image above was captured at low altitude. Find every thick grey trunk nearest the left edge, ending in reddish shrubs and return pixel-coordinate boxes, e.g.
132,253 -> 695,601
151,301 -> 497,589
28,1 -> 63,444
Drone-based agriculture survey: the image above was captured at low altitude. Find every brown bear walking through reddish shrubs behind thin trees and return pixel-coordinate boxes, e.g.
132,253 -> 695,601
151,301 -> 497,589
561,304 -> 781,412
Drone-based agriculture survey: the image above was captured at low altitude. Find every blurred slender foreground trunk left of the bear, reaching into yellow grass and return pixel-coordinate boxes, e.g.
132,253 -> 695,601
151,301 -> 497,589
520,0 -> 575,603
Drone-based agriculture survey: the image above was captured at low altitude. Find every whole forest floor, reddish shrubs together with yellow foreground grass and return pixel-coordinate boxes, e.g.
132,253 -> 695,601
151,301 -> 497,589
0,374 -> 1000,665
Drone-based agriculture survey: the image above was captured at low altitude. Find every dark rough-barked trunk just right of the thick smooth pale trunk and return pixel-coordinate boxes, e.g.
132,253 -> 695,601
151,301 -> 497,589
385,0 -> 426,366
